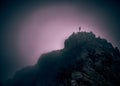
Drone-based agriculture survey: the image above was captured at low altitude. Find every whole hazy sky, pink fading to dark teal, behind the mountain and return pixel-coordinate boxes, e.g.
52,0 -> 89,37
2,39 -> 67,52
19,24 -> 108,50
0,0 -> 120,80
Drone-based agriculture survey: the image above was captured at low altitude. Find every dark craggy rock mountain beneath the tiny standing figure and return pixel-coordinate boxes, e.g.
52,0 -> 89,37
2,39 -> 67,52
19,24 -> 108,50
6,32 -> 120,86
